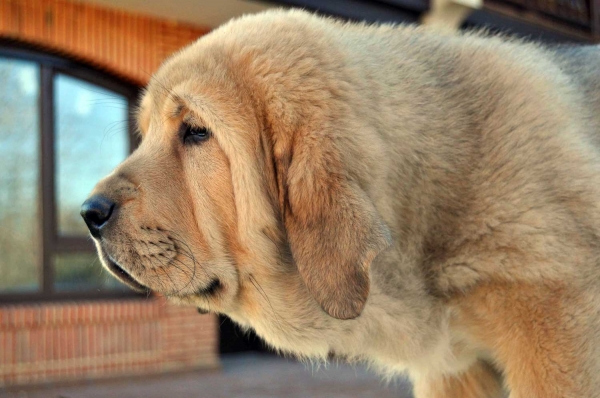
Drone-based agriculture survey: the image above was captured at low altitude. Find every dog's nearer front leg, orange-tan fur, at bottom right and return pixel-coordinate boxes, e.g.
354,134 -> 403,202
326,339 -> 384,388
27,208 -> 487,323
457,283 -> 598,398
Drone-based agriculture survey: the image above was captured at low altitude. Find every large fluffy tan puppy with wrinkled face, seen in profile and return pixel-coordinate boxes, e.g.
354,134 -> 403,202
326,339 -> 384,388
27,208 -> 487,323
82,11 -> 600,398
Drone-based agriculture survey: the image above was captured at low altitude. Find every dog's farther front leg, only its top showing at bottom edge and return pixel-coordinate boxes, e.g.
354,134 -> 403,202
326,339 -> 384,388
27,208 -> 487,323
413,361 -> 504,398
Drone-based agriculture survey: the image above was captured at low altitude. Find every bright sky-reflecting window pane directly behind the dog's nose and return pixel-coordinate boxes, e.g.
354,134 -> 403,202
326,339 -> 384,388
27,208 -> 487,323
55,75 -> 129,235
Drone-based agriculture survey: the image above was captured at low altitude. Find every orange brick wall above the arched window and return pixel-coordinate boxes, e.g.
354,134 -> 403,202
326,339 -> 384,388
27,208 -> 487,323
0,0 -> 208,85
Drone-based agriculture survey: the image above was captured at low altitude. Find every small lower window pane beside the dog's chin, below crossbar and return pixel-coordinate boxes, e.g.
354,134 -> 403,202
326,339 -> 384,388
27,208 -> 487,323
54,253 -> 129,292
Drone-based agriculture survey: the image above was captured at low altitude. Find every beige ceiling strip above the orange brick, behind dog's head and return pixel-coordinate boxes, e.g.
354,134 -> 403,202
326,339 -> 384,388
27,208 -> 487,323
80,0 -> 273,28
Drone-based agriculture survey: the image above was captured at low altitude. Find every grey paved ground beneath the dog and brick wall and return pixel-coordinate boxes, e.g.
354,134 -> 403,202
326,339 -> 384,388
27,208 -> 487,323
0,354 -> 412,398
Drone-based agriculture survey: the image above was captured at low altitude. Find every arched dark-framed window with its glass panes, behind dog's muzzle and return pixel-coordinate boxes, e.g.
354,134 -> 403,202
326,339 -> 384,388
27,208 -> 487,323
0,43 -> 137,302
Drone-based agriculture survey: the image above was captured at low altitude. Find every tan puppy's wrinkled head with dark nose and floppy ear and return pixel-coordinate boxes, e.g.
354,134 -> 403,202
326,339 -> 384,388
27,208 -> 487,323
82,13 -> 389,332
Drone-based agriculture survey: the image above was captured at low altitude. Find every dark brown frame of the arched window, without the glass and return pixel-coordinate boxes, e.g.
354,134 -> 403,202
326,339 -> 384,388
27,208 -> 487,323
0,40 -> 146,305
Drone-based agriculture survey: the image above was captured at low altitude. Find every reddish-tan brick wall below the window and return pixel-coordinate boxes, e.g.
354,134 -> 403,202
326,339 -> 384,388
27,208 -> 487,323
0,298 -> 218,386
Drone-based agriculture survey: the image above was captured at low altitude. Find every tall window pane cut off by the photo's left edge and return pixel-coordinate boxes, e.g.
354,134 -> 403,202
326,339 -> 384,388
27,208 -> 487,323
0,58 -> 40,293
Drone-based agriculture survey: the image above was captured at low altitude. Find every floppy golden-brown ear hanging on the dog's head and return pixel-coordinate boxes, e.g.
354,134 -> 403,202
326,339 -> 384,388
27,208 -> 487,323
275,127 -> 390,319
